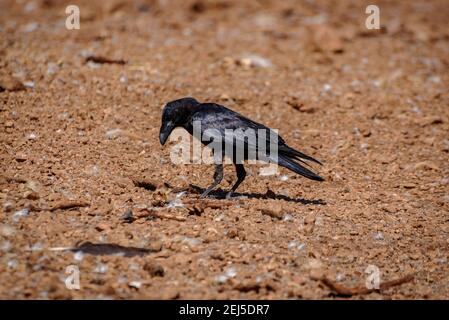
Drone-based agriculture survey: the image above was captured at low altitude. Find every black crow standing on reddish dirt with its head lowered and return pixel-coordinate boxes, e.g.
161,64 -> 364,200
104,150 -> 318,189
159,98 -> 324,198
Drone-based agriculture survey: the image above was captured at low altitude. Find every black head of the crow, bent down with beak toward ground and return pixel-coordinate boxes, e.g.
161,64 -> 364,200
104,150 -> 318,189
159,98 -> 200,145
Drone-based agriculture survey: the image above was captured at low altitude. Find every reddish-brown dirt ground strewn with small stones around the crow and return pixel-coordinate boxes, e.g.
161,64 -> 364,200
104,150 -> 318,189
0,0 -> 449,299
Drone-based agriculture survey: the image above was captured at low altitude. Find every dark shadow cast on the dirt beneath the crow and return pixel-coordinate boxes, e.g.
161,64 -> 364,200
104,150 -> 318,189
185,184 -> 326,205
